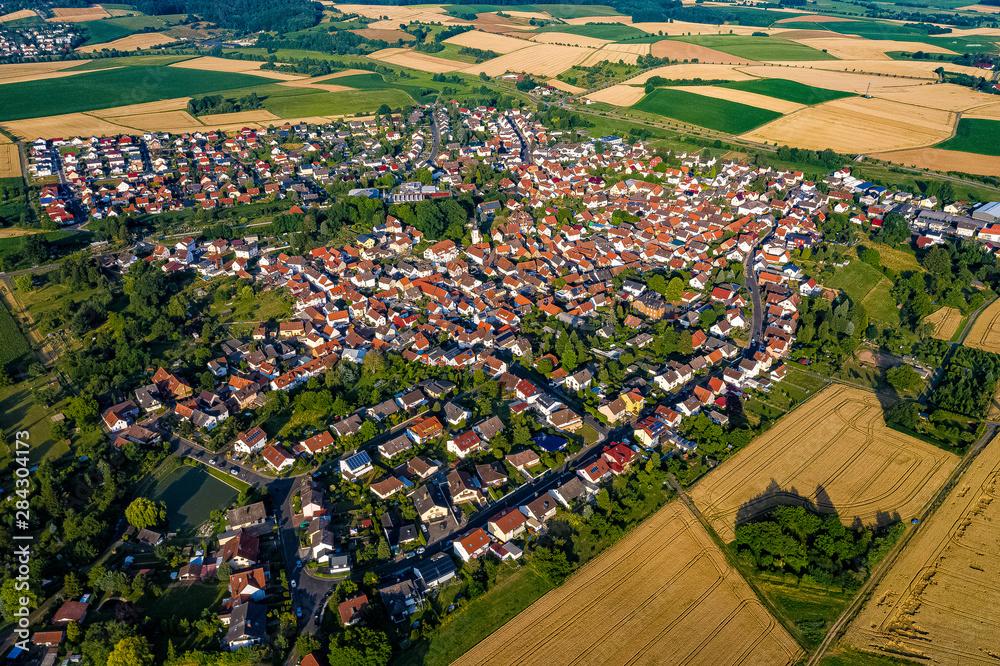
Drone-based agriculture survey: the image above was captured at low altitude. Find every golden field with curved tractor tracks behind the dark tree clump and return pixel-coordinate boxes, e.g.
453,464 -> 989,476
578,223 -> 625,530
691,384 -> 958,542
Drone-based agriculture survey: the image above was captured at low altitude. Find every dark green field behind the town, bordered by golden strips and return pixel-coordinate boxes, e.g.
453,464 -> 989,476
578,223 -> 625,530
632,88 -> 781,134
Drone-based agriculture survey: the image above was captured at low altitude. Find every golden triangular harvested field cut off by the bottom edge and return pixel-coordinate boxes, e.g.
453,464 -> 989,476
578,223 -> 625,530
455,501 -> 802,666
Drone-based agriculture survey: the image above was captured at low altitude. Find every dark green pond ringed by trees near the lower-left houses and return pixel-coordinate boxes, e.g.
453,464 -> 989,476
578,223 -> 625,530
149,466 -> 238,533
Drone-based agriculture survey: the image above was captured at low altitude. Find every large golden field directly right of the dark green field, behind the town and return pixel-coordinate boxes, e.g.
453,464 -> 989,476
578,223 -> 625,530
743,97 -> 955,153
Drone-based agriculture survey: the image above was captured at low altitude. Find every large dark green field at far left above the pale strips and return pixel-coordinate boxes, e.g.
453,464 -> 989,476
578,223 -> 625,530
0,66 -> 274,120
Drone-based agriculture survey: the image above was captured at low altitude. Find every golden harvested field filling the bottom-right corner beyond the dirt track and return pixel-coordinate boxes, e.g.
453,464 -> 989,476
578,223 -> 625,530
842,428 -> 1000,666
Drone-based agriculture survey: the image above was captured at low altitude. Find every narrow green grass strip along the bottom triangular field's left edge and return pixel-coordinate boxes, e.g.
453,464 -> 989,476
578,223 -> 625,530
423,566 -> 552,666
